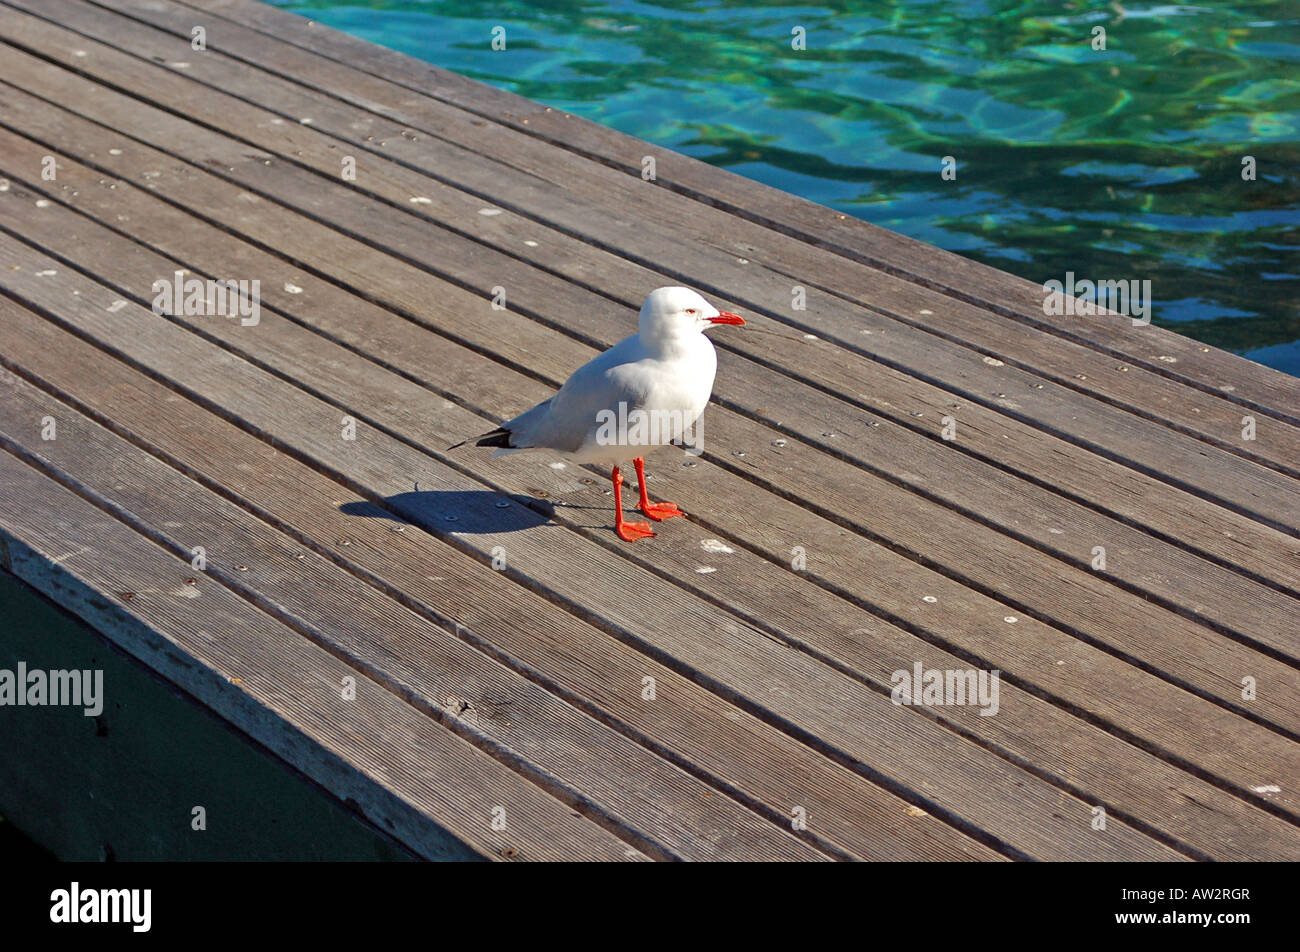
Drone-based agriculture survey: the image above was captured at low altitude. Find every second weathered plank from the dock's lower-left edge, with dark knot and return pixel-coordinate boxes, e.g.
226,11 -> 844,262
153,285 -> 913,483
0,371 -> 826,861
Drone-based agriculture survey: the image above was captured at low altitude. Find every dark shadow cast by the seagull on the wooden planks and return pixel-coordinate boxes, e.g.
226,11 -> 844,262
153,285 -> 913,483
338,489 -> 555,535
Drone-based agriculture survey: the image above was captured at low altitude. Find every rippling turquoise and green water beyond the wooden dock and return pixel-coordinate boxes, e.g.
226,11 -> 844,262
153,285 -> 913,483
274,0 -> 1300,376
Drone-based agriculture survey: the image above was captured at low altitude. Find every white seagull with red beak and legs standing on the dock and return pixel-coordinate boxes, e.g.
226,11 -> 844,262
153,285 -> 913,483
447,287 -> 745,542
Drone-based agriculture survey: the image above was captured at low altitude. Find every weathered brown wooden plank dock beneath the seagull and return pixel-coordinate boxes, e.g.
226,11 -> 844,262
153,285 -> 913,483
0,0 -> 1300,861
